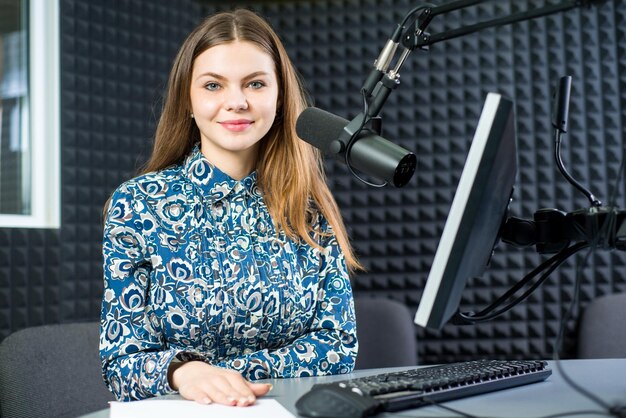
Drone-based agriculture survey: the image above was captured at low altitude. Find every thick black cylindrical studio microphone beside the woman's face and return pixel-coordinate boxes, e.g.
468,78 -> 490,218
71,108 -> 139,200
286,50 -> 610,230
296,107 -> 417,187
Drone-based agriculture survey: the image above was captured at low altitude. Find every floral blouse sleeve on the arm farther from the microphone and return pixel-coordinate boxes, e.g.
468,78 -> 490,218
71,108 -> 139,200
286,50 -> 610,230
100,185 -> 201,400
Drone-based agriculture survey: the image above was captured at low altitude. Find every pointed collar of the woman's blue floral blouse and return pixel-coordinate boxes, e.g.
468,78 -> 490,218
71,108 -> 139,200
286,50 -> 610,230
183,145 -> 257,202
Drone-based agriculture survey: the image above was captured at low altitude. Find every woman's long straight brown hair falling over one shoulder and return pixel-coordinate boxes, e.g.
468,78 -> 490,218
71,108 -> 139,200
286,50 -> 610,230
108,9 -> 361,271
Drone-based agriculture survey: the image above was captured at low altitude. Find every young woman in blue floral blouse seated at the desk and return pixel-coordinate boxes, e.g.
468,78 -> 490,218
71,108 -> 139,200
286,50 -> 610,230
100,10 -> 360,406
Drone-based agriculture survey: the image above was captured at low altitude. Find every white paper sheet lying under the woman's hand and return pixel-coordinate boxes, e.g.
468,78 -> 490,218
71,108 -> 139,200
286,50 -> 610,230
110,399 -> 295,418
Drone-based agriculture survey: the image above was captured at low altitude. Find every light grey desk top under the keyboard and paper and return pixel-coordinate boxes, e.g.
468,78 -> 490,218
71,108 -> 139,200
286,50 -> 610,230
82,359 -> 626,418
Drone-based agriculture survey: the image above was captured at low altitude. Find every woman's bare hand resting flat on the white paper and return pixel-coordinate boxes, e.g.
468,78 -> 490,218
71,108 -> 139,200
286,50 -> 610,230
168,361 -> 272,406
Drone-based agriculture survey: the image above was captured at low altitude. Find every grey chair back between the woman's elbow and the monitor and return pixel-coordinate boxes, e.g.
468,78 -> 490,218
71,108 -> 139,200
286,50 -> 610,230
354,296 -> 417,369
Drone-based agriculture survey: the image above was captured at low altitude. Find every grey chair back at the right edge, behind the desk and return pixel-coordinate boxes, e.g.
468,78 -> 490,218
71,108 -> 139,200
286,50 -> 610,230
578,293 -> 626,358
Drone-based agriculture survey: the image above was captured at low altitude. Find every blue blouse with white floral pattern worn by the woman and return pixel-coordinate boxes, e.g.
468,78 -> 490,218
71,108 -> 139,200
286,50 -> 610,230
100,147 -> 357,400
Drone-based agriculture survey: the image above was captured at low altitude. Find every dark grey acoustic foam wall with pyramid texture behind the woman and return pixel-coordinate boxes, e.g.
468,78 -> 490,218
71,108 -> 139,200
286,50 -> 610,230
0,0 -> 626,363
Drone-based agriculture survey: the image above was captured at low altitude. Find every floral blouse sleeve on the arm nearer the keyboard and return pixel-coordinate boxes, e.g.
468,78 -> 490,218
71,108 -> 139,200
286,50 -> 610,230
212,229 -> 358,380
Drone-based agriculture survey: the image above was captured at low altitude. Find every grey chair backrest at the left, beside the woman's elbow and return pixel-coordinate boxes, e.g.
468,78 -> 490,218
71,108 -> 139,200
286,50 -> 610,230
0,322 -> 114,418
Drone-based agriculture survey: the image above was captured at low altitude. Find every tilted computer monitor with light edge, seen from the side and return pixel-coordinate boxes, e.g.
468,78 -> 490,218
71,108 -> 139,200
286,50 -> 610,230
415,93 -> 517,329
